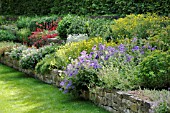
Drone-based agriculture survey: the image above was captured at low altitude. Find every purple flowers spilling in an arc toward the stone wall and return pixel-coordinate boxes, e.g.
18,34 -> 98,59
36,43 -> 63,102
60,39 -> 156,92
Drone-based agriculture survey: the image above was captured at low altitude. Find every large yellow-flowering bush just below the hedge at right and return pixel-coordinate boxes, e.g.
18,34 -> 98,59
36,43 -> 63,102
111,14 -> 170,39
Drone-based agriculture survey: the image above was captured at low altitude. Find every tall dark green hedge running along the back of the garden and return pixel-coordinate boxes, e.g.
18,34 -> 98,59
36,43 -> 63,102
0,0 -> 170,15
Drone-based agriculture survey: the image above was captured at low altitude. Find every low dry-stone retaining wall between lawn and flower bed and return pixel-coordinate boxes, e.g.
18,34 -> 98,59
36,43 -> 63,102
0,55 -> 156,113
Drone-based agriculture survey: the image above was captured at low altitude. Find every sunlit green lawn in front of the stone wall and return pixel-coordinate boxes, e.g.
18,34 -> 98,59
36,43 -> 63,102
0,64 -> 108,113
